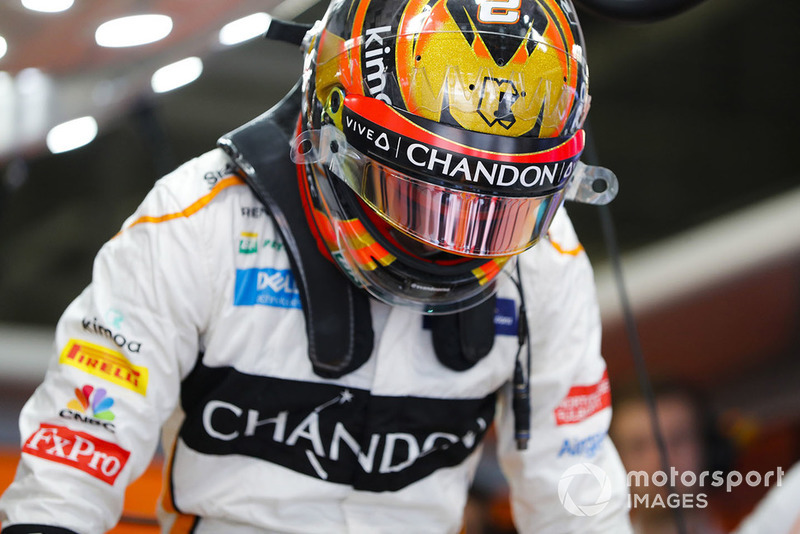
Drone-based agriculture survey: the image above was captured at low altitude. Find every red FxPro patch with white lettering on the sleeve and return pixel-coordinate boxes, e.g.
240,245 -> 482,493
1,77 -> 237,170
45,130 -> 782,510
22,423 -> 130,485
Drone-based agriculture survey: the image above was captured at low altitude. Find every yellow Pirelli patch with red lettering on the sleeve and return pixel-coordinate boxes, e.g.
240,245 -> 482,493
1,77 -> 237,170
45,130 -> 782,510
58,339 -> 147,396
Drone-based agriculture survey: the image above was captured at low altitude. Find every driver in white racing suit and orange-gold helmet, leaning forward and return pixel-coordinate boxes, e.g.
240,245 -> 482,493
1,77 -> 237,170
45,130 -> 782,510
0,0 -> 630,534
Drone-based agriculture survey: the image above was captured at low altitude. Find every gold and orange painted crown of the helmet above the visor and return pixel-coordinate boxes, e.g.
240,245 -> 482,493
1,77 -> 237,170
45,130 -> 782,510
315,0 -> 588,137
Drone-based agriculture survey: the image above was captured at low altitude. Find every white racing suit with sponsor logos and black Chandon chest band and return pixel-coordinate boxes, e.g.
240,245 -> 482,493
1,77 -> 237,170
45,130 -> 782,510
0,149 -> 630,534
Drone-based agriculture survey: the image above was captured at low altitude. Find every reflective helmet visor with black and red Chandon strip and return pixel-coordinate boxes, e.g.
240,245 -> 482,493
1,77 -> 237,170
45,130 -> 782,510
293,96 -> 583,257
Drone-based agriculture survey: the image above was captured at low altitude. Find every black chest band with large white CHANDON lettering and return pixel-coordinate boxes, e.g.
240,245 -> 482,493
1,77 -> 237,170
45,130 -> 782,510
181,364 -> 495,491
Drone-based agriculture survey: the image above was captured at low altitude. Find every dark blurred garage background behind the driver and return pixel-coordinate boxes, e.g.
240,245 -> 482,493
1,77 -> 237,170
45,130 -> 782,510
0,0 -> 800,526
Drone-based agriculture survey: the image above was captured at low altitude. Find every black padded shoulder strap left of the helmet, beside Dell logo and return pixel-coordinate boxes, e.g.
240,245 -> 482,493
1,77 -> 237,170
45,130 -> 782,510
218,85 -> 373,378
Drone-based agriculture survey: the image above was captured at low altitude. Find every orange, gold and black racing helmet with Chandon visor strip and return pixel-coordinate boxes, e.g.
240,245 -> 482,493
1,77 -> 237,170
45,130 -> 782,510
292,0 -> 589,314
